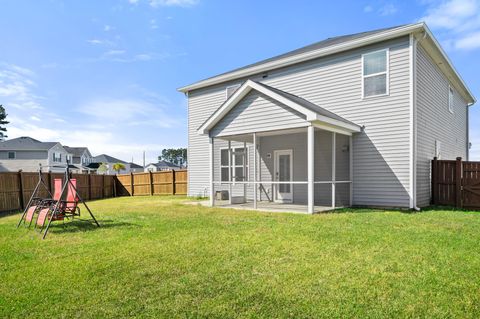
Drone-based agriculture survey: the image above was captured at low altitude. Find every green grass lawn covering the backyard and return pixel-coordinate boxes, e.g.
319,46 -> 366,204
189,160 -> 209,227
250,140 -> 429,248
0,197 -> 480,318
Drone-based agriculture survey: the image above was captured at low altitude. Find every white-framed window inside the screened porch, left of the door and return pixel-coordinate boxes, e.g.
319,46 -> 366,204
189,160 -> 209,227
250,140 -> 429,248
220,147 -> 248,182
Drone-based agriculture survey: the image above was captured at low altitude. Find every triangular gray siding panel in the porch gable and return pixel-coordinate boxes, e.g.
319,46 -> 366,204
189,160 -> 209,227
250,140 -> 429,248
210,90 -> 309,136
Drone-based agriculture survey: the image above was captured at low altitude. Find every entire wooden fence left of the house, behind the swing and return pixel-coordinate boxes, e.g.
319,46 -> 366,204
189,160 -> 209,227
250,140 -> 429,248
0,170 -> 187,212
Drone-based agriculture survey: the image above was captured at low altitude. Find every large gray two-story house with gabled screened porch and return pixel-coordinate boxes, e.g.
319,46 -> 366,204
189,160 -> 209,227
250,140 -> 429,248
179,23 -> 475,213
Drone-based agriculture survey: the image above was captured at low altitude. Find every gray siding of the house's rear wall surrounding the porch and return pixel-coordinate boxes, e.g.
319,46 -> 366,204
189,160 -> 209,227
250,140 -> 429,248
189,37 -> 410,207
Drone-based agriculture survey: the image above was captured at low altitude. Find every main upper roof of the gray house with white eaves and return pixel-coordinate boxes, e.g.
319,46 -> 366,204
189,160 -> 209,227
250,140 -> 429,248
178,22 -> 476,105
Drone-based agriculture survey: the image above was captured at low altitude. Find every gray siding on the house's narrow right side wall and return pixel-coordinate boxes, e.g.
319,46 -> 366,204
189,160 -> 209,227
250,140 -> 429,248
415,45 -> 468,207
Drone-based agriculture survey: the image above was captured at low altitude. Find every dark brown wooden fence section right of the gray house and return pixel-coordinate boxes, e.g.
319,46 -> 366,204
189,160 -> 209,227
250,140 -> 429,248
432,157 -> 480,209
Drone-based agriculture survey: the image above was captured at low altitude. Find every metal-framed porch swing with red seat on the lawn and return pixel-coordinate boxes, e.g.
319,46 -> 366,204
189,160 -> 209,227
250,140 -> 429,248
17,162 -> 100,239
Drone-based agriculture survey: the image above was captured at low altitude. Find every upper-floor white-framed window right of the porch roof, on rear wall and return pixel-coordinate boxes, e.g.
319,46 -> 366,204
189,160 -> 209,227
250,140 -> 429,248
362,49 -> 389,98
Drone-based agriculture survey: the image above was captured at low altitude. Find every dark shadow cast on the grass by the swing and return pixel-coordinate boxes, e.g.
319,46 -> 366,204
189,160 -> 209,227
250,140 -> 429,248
49,219 -> 142,234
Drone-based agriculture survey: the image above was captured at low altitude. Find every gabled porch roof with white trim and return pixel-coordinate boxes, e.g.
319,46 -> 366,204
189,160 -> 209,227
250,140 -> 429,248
198,80 -> 361,134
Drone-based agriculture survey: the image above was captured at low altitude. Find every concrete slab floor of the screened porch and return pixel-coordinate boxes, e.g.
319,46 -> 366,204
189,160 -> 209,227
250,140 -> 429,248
187,200 -> 340,214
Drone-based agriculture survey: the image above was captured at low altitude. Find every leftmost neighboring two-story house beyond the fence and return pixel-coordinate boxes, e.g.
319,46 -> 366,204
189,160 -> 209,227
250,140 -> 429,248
0,136 -> 70,172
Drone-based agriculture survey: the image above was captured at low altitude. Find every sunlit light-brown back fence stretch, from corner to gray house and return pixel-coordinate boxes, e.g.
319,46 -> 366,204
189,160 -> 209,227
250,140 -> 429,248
117,170 -> 187,196
